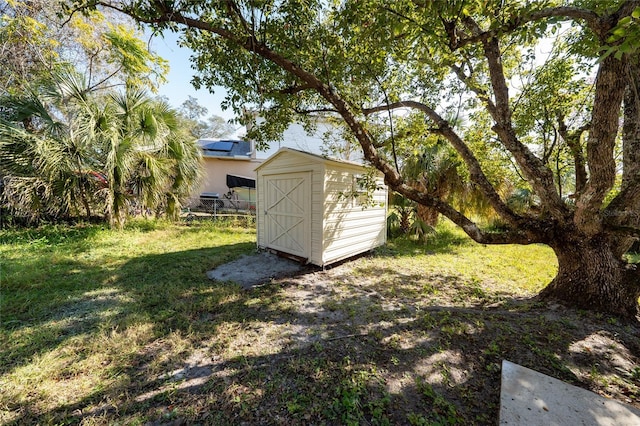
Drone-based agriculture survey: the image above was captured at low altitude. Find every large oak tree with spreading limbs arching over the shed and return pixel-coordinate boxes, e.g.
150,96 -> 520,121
75,0 -> 640,317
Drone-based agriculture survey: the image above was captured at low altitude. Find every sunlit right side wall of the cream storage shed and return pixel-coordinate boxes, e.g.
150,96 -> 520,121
322,166 -> 387,265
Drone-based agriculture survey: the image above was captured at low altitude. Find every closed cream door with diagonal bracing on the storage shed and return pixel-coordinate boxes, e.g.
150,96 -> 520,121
264,173 -> 311,259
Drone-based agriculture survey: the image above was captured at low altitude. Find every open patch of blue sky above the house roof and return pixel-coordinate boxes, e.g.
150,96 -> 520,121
151,31 -> 234,120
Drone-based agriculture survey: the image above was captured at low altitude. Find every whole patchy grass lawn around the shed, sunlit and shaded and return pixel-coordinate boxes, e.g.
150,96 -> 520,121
0,218 -> 640,425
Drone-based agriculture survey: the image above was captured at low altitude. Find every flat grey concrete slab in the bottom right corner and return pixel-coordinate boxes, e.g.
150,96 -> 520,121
500,360 -> 640,426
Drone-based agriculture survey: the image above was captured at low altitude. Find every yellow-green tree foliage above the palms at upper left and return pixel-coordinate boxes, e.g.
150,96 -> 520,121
0,0 -> 168,95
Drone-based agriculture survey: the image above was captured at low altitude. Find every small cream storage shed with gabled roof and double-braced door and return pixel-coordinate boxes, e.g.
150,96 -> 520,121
256,148 -> 387,266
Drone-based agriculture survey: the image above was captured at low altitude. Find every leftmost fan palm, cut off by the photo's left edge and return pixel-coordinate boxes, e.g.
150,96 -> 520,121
0,70 -> 90,218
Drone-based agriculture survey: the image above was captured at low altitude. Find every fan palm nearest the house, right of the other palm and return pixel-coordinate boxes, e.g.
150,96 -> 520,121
101,89 -> 202,226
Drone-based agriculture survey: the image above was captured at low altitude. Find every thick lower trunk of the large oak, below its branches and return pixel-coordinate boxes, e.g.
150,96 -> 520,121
540,235 -> 640,319
